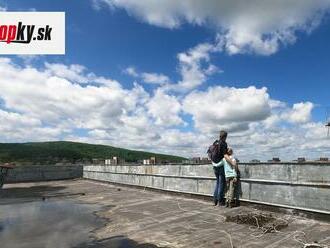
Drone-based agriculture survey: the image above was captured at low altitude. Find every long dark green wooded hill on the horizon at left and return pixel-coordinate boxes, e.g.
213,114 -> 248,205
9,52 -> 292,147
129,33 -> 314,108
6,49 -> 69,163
0,141 -> 185,164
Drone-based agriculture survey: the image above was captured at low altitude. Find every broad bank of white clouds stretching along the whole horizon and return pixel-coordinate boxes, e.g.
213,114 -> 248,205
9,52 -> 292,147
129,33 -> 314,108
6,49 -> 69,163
0,55 -> 330,160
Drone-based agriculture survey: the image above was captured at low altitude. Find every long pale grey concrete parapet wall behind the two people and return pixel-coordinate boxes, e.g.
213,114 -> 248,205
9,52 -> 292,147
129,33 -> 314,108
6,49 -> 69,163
83,163 -> 330,214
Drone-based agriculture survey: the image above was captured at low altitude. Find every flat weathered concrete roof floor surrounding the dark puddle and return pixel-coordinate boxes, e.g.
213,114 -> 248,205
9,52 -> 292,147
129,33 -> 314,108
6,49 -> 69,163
0,180 -> 330,248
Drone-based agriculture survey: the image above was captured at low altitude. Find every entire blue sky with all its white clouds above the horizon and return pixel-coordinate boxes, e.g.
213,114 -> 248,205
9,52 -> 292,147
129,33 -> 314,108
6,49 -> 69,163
0,0 -> 330,161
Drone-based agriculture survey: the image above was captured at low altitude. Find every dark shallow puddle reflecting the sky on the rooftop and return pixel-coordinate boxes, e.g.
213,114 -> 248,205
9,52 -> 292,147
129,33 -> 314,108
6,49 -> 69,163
0,200 -> 162,248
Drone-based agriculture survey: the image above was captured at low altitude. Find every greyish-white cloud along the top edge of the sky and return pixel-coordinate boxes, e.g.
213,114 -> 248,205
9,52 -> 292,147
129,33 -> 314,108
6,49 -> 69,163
93,0 -> 330,55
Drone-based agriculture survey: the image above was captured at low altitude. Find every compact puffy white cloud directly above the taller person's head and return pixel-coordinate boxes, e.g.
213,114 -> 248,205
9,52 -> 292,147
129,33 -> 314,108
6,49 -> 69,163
183,86 -> 271,132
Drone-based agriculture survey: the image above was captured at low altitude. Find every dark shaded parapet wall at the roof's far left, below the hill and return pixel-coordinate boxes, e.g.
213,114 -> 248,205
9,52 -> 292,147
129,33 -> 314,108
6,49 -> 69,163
5,165 -> 83,183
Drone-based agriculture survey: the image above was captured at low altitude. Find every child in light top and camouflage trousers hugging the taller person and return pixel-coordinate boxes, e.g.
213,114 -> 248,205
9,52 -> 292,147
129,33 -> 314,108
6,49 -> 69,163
222,148 -> 238,208
